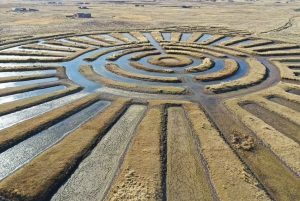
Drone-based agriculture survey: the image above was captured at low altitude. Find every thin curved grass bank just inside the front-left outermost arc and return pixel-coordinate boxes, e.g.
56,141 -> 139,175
105,63 -> 181,83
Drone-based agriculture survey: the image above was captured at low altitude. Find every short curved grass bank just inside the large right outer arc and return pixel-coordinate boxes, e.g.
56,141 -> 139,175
194,59 -> 239,82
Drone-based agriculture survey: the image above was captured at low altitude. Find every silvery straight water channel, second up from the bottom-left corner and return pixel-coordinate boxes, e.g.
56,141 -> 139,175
0,92 -> 87,130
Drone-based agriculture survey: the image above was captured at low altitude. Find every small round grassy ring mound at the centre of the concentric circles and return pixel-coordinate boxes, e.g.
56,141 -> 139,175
148,54 -> 193,67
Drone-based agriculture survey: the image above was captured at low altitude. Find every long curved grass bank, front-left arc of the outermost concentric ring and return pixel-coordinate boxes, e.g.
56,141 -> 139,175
79,65 -> 188,94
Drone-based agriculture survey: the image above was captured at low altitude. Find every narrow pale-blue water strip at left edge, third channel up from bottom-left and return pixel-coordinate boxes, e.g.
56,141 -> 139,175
0,86 -> 65,104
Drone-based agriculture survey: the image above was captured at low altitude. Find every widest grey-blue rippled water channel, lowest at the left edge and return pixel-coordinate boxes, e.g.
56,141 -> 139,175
0,101 -> 110,180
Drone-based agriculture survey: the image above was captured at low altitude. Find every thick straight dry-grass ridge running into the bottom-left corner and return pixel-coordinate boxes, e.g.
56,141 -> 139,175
0,98 -> 130,201
